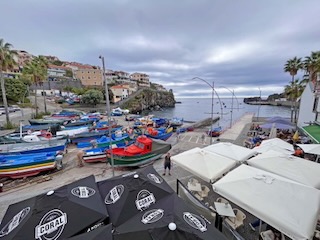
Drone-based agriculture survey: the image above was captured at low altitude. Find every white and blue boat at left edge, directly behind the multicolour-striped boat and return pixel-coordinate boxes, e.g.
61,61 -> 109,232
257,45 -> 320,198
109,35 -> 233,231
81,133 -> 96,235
0,139 -> 67,155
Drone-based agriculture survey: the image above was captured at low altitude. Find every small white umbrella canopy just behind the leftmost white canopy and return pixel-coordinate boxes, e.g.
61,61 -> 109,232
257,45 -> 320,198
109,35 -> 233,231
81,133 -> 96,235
203,142 -> 257,162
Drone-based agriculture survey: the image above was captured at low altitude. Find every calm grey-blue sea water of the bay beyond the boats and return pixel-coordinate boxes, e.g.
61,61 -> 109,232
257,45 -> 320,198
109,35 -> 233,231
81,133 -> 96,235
150,98 -> 290,128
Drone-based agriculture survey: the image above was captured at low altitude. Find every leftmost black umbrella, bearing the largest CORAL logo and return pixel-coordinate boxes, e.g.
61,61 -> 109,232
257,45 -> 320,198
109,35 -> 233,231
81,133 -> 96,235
0,176 -> 108,240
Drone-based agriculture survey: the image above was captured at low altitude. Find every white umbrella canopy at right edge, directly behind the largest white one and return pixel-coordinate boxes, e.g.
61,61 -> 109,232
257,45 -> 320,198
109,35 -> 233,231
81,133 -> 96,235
248,150 -> 320,189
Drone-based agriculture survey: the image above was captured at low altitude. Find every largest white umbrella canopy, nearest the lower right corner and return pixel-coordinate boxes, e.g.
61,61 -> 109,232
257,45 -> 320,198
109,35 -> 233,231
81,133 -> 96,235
213,165 -> 320,240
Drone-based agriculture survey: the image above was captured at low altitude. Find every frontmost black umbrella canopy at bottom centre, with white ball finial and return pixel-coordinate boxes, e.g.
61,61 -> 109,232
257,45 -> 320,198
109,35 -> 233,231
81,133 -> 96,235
114,194 -> 226,240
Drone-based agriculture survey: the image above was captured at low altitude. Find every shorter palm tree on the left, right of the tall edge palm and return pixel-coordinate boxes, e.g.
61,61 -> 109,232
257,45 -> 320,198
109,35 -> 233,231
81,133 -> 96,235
23,57 -> 47,115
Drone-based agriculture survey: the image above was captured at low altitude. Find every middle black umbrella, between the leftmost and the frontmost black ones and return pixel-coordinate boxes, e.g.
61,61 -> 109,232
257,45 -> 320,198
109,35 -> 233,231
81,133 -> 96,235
98,166 -> 174,226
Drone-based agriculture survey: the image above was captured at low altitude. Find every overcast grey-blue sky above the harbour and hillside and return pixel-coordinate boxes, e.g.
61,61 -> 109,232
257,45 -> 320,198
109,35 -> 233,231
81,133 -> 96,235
0,0 -> 320,98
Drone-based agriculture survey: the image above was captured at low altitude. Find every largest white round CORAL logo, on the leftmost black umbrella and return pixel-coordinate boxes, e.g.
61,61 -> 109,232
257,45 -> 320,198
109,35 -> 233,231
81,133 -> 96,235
35,209 -> 67,240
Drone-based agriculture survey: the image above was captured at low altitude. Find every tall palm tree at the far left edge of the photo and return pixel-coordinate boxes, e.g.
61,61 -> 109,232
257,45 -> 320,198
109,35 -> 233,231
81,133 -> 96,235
0,38 -> 16,125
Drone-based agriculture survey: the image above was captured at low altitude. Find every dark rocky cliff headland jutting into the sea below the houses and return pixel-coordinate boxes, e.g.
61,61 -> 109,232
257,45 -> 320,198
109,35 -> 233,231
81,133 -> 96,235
121,88 -> 176,113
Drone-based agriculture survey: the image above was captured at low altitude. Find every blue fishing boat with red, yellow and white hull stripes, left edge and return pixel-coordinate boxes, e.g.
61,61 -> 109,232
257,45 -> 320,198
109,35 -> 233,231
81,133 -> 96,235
0,152 -> 63,179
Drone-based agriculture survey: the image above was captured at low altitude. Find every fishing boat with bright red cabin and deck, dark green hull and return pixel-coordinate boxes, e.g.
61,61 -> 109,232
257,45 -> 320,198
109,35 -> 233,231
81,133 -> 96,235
107,135 -> 171,167
